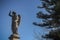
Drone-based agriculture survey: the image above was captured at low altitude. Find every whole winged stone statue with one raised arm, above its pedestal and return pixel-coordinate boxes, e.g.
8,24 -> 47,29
9,11 -> 21,34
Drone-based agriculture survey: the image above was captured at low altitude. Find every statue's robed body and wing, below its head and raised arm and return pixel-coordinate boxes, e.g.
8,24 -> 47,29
12,15 -> 20,34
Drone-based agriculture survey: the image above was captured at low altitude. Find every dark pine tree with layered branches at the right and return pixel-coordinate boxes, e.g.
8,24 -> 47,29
33,0 -> 60,40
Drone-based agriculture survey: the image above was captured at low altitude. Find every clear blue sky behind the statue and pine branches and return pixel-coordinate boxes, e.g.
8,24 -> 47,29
0,0 -> 46,40
